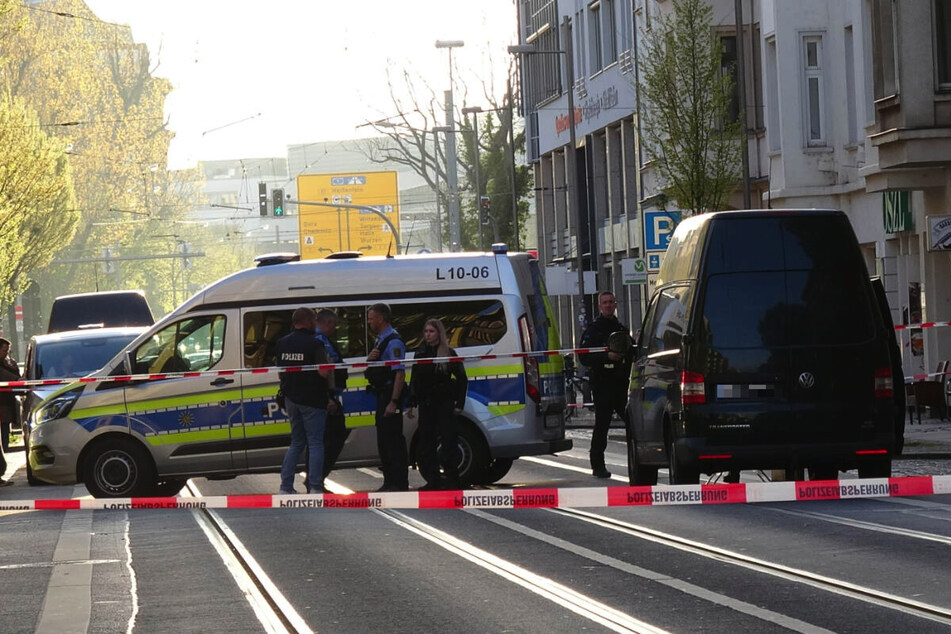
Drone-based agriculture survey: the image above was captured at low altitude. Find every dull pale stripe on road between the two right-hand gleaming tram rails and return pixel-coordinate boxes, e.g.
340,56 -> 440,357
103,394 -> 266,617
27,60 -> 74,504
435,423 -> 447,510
465,509 -> 831,634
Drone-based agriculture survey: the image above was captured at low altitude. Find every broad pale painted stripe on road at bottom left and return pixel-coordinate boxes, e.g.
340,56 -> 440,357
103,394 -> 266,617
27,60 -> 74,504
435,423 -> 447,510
36,485 -> 93,634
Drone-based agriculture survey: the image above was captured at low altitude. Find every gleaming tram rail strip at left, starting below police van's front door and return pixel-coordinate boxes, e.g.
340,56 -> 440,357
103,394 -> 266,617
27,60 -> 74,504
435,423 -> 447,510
189,481 -> 312,634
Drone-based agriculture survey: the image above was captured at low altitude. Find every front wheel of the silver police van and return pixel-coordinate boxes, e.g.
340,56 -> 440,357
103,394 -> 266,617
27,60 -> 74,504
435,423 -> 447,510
83,438 -> 156,498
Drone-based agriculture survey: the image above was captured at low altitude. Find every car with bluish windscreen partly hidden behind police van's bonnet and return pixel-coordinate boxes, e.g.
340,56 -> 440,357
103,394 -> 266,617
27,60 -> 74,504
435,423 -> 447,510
20,326 -> 147,484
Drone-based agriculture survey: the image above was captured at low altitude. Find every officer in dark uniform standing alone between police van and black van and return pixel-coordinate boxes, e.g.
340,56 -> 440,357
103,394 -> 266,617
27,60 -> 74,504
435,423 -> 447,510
579,291 -> 631,478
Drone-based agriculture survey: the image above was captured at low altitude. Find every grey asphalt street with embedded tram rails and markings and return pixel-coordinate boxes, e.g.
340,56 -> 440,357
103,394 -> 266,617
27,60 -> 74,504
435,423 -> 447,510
0,430 -> 951,633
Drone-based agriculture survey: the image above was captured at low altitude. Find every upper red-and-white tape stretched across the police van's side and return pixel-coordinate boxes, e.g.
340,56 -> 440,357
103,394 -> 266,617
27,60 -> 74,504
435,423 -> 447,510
0,347 -> 608,392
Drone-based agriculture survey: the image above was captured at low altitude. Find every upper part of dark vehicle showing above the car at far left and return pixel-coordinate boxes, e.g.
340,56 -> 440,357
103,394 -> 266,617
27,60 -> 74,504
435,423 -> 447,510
46,291 -> 155,334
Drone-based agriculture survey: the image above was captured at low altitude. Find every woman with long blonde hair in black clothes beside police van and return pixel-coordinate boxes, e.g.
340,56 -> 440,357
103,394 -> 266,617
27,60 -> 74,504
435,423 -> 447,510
409,319 -> 468,491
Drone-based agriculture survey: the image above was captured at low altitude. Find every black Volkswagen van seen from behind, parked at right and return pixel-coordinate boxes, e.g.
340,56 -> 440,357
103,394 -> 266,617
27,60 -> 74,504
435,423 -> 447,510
612,210 -> 896,484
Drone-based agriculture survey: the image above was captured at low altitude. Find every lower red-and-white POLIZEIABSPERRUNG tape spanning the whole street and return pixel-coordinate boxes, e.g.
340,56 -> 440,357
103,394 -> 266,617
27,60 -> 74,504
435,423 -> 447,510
0,475 -> 951,511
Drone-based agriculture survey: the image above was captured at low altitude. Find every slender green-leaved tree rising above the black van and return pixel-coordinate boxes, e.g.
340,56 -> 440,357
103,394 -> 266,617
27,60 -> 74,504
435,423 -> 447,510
640,0 -> 742,215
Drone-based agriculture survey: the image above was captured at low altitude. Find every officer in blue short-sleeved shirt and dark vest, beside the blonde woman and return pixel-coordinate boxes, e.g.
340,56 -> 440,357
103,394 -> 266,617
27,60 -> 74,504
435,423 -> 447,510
365,303 -> 409,491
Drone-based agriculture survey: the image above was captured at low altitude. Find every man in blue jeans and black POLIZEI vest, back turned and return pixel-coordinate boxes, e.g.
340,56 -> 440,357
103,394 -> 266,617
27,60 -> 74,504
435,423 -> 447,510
276,306 -> 333,494
